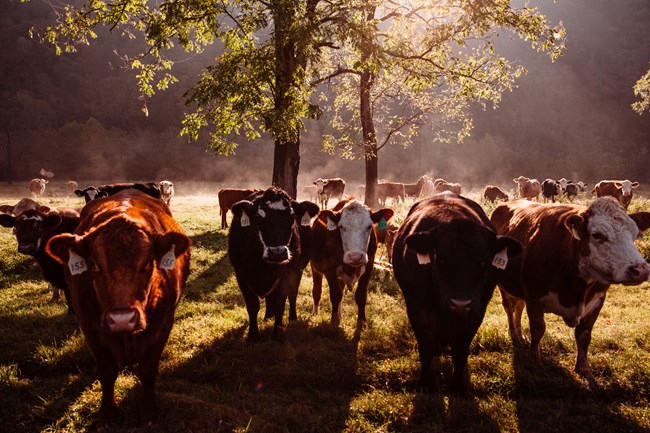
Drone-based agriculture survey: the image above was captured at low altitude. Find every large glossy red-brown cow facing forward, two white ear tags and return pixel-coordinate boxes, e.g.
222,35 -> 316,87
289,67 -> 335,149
46,189 -> 191,423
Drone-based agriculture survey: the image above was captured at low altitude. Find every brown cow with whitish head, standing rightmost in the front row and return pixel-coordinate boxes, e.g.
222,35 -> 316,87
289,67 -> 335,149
490,197 -> 650,381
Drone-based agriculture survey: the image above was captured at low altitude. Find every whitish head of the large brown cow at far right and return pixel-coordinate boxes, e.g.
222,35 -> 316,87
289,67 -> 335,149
564,197 -> 650,285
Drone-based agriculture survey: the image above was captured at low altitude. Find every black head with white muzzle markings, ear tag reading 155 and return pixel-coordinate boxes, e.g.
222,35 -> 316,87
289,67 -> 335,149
231,187 -> 319,265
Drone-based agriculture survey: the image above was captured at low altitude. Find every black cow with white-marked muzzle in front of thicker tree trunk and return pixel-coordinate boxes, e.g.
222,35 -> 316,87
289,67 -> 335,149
228,187 -> 319,342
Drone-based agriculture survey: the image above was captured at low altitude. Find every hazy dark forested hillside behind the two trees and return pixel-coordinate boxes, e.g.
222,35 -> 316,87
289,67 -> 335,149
0,0 -> 650,186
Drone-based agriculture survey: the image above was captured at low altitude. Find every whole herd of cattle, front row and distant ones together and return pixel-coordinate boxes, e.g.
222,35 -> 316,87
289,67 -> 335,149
0,176 -> 650,421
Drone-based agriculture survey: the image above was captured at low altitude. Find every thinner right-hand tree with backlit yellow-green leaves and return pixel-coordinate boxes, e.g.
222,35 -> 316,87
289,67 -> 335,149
317,0 -> 565,206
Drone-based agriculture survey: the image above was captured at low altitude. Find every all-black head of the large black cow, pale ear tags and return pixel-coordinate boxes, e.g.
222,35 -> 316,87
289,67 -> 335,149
405,220 -> 522,314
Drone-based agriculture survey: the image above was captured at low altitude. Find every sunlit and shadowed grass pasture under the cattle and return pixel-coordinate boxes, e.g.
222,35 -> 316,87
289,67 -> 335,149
0,183 -> 650,433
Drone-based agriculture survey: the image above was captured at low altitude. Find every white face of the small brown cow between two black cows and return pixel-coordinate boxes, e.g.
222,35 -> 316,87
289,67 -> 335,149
339,200 -> 372,266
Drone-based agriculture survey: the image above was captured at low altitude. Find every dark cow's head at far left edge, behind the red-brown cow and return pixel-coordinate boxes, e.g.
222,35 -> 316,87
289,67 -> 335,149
0,206 -> 62,255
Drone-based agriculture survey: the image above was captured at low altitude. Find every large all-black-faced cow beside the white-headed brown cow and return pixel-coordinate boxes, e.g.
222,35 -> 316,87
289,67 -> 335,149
393,192 -> 521,391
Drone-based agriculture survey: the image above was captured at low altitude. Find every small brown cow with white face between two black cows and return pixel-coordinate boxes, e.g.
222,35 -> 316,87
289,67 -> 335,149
311,199 -> 394,329
